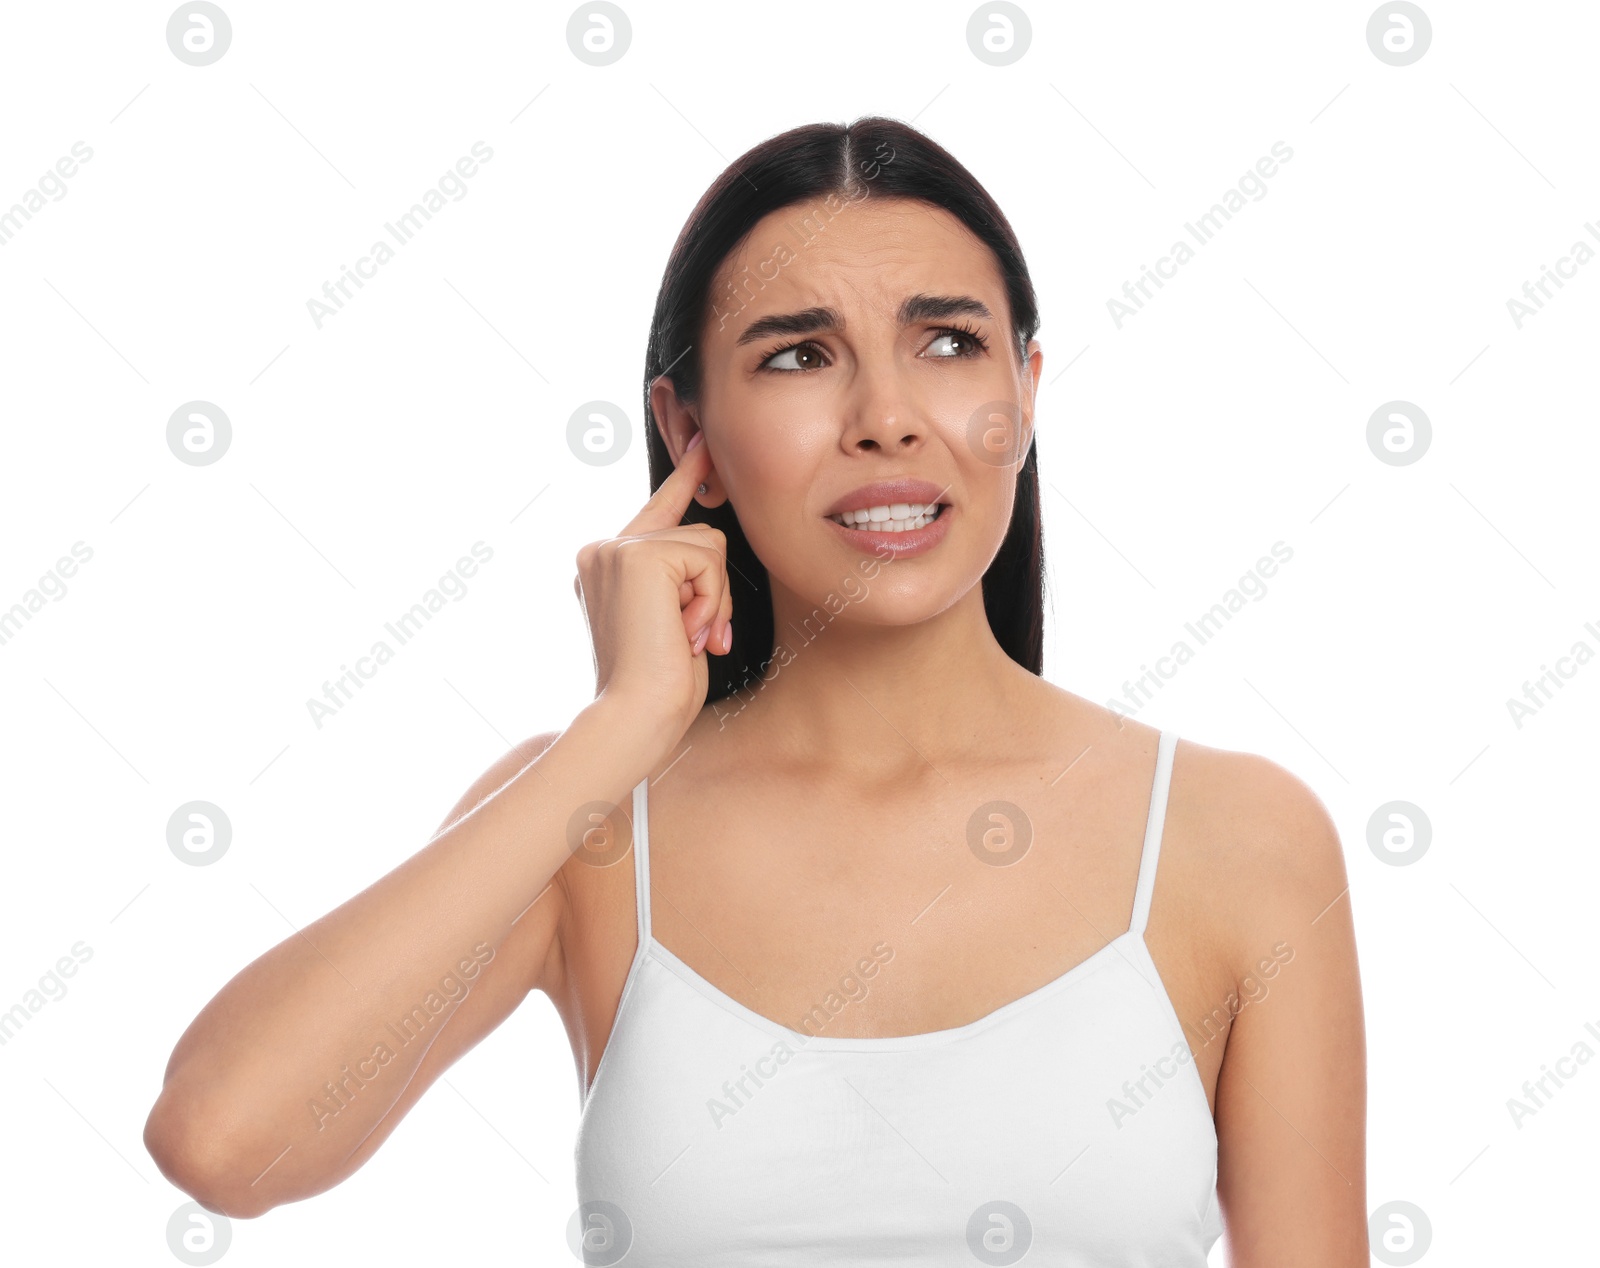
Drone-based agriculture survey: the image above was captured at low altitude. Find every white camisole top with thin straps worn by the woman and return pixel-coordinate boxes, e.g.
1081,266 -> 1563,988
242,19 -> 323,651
568,732 -> 1222,1268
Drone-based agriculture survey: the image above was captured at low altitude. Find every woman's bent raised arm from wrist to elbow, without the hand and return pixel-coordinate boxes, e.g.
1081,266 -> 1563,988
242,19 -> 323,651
144,701 -> 653,1218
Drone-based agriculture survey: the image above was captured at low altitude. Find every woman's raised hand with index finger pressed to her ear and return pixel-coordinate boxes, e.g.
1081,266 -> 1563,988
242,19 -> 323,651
573,432 -> 733,751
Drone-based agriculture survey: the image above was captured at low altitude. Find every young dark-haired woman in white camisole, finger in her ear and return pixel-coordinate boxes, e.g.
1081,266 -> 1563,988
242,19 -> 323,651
146,118 -> 1368,1268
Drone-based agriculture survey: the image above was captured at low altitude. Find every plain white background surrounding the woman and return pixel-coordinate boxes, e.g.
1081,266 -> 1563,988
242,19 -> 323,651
0,0 -> 1600,1265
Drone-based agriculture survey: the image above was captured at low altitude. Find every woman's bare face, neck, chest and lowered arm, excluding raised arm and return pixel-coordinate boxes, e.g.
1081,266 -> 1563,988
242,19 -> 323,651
554,190 -> 1368,1268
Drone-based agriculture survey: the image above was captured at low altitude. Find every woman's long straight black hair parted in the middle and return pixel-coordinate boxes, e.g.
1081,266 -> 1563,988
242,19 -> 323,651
643,115 -> 1045,704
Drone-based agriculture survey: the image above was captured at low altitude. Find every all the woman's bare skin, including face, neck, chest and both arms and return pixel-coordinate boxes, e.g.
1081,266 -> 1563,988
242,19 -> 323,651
147,190 -> 1368,1268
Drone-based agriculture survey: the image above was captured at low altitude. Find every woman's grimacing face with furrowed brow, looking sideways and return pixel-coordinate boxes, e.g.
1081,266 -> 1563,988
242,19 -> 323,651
656,197 -> 1042,624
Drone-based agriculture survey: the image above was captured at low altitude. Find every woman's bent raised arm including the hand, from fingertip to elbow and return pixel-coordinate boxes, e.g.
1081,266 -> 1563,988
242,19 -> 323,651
144,432 -> 731,1217
